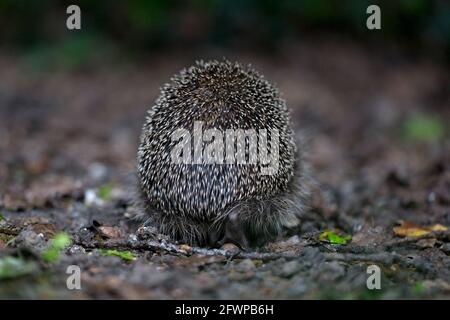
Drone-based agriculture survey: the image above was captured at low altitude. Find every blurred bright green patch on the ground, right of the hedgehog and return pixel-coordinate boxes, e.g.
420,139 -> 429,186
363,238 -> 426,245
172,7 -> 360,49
403,114 -> 446,142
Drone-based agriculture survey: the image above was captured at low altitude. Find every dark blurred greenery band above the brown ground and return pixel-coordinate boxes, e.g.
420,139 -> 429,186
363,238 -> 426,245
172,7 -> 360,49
0,0 -> 450,57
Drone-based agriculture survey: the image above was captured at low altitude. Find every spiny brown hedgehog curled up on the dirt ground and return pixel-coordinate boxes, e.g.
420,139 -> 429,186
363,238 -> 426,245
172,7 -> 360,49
137,59 -> 309,249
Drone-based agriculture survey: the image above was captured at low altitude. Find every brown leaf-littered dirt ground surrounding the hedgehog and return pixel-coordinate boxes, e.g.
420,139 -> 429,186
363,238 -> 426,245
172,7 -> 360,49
0,39 -> 450,299
